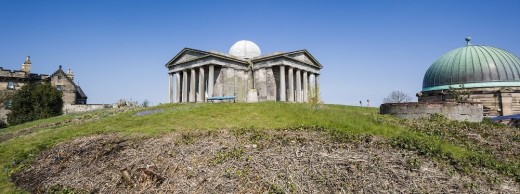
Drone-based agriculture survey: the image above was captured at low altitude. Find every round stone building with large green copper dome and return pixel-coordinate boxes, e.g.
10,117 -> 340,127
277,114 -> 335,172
418,37 -> 520,115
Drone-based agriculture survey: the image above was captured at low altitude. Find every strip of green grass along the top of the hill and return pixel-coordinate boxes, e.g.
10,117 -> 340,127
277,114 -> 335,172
0,102 -> 520,193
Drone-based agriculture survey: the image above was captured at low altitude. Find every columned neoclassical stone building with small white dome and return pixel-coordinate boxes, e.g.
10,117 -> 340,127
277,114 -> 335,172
165,40 -> 322,103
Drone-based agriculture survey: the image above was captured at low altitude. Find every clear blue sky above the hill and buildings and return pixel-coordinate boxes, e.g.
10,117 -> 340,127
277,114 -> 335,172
0,0 -> 520,106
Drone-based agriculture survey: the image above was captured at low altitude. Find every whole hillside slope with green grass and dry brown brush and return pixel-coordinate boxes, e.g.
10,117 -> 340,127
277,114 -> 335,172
0,103 -> 520,193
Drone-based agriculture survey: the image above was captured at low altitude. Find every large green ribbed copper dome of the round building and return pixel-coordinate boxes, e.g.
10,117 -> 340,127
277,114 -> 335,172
423,37 -> 520,91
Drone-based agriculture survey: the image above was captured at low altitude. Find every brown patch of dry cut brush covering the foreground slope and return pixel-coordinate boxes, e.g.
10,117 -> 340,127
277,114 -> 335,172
12,130 -> 520,193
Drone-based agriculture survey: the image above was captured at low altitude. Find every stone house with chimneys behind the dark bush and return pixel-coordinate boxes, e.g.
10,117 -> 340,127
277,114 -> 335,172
0,56 -> 87,121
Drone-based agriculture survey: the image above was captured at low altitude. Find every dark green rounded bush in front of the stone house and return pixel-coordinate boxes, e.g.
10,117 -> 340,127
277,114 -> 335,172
7,83 -> 63,125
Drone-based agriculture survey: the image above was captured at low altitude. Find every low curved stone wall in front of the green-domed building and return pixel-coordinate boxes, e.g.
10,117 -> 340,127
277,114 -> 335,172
379,102 -> 483,122
